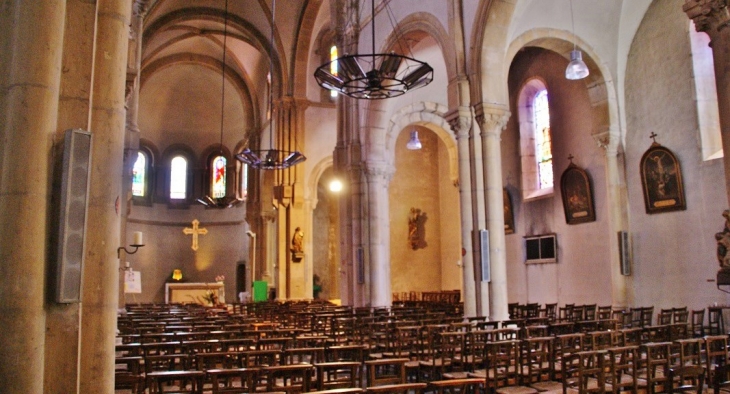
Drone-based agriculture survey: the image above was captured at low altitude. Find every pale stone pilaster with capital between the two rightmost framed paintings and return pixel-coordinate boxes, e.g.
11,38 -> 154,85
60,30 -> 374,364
593,130 -> 631,307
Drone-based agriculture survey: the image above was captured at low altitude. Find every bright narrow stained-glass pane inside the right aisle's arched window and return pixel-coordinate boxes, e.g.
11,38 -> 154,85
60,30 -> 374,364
532,89 -> 553,189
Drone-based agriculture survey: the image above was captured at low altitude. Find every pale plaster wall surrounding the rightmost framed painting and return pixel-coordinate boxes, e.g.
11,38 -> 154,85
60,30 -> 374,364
626,0 -> 728,308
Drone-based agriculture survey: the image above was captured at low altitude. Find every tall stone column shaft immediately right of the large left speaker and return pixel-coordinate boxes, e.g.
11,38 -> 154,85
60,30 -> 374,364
80,0 -> 132,393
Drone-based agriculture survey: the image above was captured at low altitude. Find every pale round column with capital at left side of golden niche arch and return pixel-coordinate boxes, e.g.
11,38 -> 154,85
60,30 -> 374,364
365,162 -> 394,307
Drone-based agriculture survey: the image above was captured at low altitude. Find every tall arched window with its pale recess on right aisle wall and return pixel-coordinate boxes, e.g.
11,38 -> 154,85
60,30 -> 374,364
518,78 -> 555,200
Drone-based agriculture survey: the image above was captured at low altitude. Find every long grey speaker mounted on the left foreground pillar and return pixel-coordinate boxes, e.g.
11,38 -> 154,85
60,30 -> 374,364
55,129 -> 91,303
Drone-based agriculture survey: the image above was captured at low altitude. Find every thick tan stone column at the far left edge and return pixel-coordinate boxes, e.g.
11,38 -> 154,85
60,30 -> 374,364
0,0 -> 66,394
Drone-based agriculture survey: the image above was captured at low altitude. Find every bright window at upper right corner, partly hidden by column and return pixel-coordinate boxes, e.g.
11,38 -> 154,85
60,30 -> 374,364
689,20 -> 723,160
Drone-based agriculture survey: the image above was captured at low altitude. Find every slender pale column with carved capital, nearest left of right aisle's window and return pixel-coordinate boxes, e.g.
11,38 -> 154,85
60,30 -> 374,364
476,104 -> 510,320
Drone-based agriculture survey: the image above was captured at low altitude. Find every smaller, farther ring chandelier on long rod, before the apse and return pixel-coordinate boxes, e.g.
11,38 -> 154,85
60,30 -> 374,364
236,0 -> 307,170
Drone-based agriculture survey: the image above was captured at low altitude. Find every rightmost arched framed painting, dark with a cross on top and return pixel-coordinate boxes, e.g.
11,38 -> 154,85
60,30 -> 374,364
640,141 -> 687,214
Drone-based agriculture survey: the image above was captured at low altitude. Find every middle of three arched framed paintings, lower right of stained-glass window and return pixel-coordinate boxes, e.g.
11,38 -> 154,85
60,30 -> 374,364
560,161 -> 596,224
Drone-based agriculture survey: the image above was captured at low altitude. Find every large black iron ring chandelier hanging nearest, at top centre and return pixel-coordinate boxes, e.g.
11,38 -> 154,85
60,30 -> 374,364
314,0 -> 433,100
